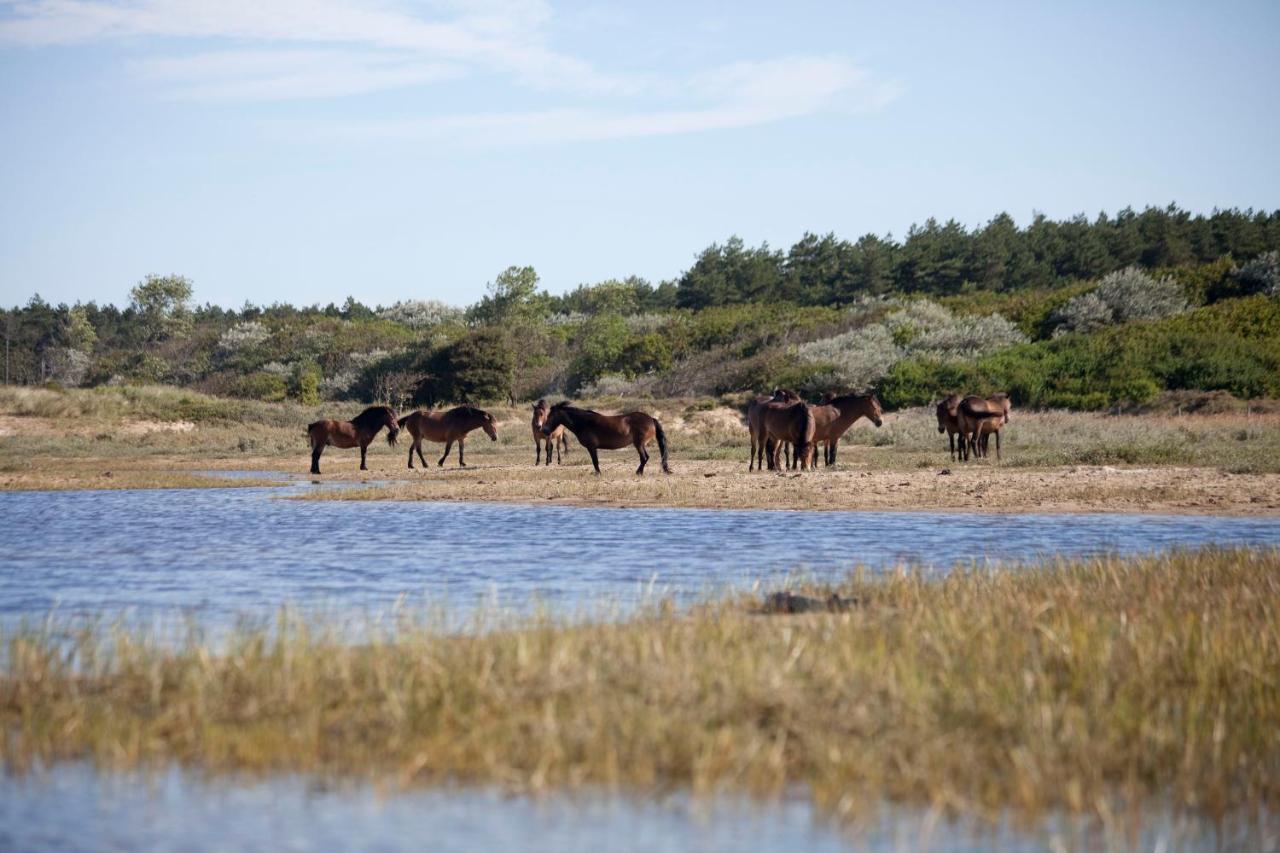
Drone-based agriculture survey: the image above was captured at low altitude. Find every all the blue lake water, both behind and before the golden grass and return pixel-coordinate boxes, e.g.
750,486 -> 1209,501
0,475 -> 1280,853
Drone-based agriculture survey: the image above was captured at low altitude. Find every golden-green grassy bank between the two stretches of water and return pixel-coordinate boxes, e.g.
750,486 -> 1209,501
0,549 -> 1280,820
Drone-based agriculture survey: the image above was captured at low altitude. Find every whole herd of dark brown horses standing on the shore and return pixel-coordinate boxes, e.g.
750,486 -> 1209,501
307,388 -> 1010,474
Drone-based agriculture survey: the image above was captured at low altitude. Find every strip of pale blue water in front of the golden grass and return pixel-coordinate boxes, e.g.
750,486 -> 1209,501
0,765 -> 1244,853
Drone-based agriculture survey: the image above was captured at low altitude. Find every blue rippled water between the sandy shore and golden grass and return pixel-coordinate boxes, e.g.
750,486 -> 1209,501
0,482 -> 1280,624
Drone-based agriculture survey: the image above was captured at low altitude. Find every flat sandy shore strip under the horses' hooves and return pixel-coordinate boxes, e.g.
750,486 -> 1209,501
0,444 -> 1280,516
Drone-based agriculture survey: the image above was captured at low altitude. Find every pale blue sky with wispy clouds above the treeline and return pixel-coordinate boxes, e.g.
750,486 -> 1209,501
0,0 -> 1280,307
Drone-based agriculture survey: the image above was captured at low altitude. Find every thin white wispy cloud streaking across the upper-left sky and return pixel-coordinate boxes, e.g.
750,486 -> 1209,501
0,0 -> 897,141
